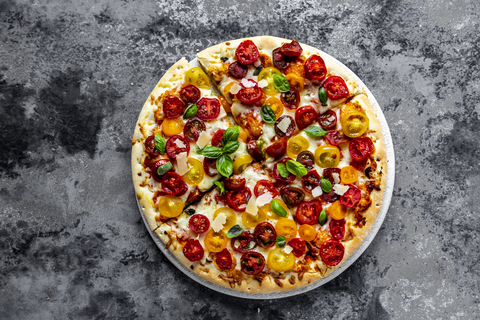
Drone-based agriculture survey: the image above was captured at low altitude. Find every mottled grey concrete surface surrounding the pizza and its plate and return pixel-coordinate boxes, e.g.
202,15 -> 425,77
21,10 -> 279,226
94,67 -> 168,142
0,0 -> 480,319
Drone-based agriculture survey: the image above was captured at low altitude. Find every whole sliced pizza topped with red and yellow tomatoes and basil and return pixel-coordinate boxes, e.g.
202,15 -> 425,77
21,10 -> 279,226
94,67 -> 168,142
132,36 -> 387,293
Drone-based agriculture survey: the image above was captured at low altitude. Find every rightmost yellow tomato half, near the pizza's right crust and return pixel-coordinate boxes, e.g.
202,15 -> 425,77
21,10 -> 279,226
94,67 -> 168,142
340,103 -> 370,138
